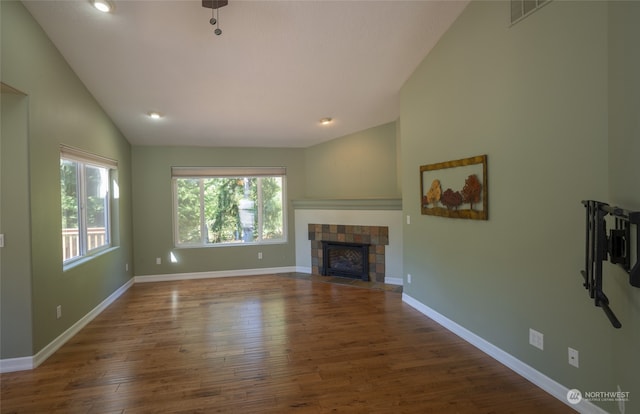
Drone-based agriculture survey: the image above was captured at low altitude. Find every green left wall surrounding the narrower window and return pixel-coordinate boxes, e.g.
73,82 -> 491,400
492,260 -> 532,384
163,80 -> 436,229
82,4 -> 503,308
1,1 -> 133,359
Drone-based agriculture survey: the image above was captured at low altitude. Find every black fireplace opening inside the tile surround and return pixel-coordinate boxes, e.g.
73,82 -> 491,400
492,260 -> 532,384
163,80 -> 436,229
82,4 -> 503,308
321,241 -> 369,281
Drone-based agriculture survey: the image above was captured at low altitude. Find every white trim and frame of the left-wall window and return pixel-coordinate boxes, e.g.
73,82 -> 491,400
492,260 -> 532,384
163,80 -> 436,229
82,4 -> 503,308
59,145 -> 118,269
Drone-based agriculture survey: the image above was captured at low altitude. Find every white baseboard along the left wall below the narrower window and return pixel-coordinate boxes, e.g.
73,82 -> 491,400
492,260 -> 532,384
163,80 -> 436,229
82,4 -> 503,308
0,279 -> 134,373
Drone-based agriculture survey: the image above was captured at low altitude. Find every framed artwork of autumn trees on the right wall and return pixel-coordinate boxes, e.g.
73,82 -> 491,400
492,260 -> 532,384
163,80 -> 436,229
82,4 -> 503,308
420,155 -> 489,220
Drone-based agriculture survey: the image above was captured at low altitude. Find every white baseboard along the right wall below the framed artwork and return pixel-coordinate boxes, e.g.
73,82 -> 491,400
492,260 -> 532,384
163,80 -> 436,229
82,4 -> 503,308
402,293 -> 607,414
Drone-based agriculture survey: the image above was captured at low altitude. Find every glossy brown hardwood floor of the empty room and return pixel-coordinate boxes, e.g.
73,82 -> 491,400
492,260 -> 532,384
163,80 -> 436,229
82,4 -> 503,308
0,275 -> 574,414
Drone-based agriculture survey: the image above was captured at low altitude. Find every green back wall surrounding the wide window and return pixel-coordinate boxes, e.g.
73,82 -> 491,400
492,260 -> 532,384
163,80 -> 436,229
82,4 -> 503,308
133,147 -> 305,276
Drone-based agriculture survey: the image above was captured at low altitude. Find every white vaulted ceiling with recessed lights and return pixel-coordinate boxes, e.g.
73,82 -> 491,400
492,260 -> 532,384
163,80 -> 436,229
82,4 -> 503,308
23,0 -> 468,147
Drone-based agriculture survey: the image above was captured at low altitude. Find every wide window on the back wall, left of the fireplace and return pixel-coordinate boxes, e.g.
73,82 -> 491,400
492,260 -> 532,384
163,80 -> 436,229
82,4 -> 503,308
172,167 -> 286,247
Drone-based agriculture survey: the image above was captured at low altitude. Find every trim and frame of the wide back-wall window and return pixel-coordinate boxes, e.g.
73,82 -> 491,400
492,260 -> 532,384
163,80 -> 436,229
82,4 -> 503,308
171,167 -> 289,249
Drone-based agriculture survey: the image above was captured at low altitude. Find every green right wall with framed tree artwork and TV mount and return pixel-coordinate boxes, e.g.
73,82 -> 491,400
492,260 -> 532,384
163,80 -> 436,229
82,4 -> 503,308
400,1 -> 640,412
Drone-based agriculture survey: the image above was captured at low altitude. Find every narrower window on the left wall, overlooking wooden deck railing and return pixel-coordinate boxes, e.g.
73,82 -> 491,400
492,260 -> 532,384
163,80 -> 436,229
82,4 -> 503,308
60,147 -> 117,263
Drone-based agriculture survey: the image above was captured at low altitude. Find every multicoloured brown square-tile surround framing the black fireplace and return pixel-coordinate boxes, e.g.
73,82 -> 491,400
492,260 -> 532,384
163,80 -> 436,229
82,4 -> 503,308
309,224 -> 389,282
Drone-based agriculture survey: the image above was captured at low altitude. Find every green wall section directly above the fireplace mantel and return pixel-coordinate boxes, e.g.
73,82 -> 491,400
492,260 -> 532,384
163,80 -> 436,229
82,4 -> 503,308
305,122 -> 400,199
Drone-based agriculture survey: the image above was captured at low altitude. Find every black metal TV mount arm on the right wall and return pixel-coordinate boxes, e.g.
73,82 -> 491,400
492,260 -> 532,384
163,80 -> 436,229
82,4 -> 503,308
580,200 -> 640,328
